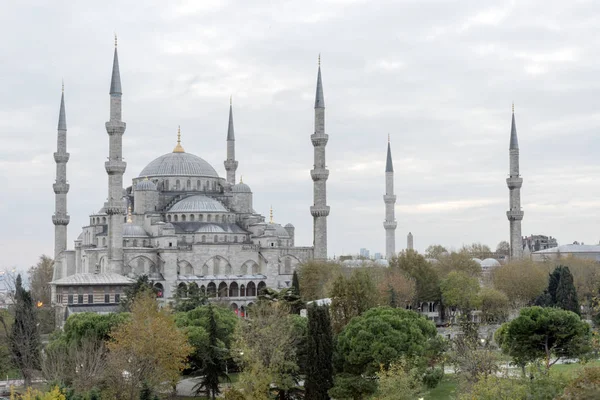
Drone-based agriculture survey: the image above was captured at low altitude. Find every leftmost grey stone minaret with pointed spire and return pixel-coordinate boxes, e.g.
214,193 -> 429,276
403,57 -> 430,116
52,84 -> 70,260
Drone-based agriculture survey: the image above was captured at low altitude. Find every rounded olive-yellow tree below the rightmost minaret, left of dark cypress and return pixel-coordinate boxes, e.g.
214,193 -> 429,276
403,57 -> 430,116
492,260 -> 547,310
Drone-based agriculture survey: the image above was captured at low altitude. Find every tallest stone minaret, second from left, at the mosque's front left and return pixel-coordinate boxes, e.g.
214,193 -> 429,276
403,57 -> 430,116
104,36 -> 127,274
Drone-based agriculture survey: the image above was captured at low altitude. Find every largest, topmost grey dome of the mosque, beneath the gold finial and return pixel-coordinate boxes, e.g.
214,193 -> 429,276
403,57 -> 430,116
139,153 -> 219,178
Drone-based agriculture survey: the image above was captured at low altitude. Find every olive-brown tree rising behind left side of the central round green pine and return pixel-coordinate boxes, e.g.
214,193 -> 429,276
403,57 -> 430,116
331,269 -> 377,333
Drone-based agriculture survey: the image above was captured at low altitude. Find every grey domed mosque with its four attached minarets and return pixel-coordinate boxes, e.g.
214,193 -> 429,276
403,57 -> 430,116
51,39 -> 329,323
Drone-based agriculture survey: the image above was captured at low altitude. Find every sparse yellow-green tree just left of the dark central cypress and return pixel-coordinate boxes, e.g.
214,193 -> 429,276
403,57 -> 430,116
232,302 -> 306,400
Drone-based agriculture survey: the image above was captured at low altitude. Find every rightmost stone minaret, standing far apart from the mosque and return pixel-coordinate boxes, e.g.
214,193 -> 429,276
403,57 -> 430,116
506,104 -> 523,259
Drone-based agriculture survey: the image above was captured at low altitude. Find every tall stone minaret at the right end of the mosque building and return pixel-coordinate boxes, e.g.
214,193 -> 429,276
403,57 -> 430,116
310,55 -> 329,260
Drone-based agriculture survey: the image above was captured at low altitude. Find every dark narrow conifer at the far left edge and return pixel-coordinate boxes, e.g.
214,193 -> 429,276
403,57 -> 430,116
5,274 -> 41,387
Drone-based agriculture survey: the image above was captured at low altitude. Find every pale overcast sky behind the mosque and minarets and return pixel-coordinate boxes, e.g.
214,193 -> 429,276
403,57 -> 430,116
0,0 -> 600,268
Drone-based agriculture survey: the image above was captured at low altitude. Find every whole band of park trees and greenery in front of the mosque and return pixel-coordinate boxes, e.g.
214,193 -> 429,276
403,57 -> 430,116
0,247 -> 600,400
